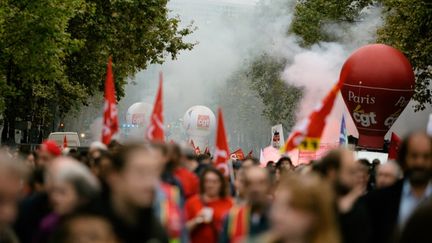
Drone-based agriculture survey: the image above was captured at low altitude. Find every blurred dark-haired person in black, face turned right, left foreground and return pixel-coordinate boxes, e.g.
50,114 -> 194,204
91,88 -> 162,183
98,144 -> 168,243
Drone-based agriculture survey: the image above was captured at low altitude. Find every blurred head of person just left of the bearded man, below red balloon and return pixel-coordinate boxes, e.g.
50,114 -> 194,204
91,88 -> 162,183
375,160 -> 402,189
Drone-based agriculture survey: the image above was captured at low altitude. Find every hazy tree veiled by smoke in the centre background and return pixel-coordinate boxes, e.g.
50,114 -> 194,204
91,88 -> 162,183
218,54 -> 302,151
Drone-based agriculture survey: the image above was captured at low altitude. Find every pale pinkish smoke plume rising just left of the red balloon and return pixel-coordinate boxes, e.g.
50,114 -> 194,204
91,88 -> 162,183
276,6 -> 383,143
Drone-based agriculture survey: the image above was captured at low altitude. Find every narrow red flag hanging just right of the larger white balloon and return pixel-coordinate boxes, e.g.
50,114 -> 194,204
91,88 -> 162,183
214,108 -> 230,176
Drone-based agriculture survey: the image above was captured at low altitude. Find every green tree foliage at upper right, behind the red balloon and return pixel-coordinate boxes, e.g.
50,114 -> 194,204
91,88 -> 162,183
290,0 -> 432,110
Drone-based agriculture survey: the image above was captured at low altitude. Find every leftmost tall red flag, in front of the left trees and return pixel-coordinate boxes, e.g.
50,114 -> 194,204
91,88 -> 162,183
102,57 -> 119,145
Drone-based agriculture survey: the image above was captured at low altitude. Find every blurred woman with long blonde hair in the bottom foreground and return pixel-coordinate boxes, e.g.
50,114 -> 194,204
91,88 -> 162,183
256,174 -> 340,243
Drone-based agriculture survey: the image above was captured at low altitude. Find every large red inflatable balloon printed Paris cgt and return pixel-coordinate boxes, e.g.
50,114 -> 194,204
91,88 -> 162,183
340,44 -> 415,150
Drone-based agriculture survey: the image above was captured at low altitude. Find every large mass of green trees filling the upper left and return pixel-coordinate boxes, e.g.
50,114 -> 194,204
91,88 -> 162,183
0,0 -> 194,143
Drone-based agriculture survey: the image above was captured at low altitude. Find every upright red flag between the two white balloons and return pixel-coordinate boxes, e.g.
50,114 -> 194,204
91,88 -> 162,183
147,72 -> 165,142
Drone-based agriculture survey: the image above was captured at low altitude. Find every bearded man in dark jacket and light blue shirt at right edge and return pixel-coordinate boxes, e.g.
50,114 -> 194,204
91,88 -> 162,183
366,133 -> 432,243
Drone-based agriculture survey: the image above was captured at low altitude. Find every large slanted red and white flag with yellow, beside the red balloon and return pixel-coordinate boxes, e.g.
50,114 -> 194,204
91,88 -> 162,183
281,78 -> 343,153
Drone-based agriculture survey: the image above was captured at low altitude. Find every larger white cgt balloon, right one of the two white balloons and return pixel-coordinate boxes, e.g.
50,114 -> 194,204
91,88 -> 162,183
183,105 -> 216,139
